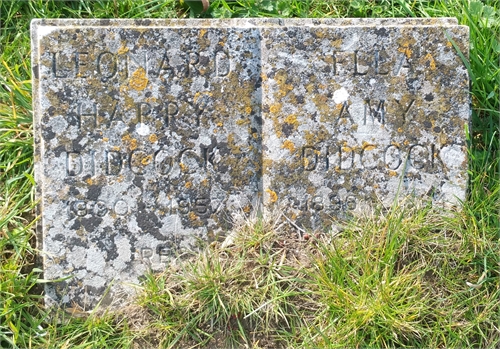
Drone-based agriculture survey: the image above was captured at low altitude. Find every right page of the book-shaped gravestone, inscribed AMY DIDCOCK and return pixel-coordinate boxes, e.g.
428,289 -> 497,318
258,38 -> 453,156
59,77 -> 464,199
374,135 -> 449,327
262,24 -> 470,229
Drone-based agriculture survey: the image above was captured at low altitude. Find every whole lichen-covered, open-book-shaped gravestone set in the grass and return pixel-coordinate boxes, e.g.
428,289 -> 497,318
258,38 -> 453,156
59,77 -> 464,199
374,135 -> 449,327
32,19 -> 469,309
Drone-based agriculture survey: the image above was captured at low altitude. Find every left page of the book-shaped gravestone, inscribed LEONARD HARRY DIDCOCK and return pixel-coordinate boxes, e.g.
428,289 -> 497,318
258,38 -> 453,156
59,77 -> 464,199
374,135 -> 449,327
32,20 -> 261,309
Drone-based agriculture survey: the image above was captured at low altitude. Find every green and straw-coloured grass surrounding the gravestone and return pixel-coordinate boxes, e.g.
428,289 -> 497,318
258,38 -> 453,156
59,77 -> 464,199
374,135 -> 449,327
0,0 -> 500,348
